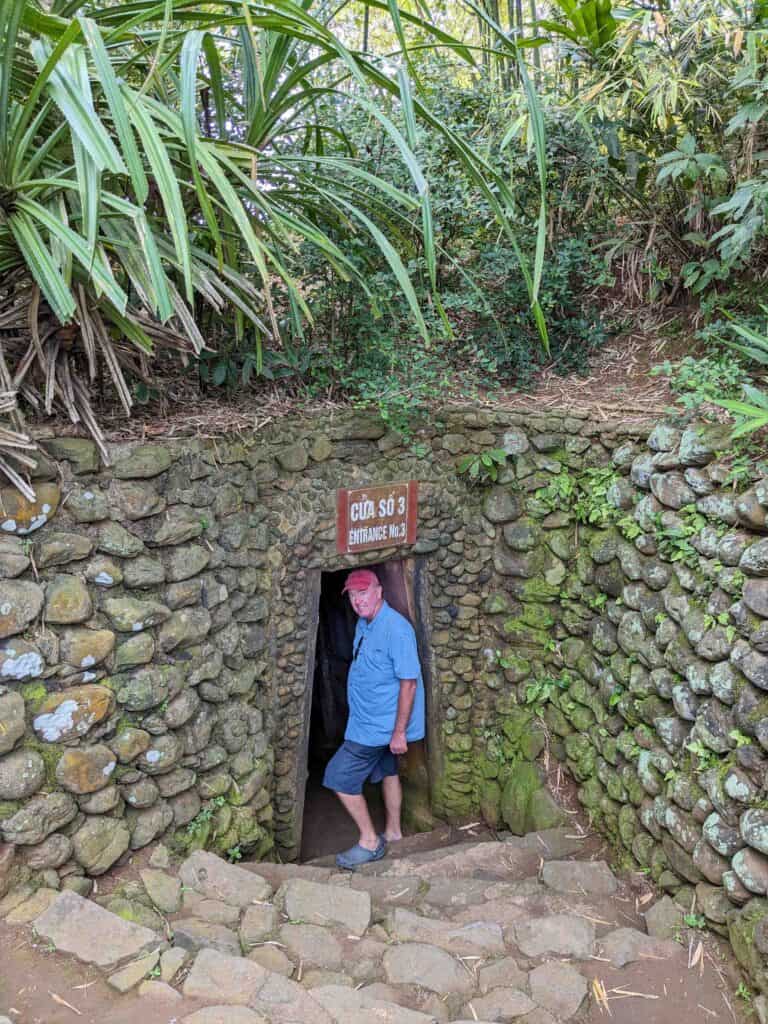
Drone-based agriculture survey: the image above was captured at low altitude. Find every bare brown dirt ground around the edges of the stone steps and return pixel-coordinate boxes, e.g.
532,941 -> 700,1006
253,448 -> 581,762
0,802 -> 756,1024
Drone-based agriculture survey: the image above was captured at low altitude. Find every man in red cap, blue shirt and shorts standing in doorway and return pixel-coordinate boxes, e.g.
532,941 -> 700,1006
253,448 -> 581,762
323,569 -> 424,870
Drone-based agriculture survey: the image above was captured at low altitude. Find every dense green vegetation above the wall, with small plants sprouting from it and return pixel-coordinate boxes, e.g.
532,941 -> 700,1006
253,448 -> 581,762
0,0 -> 768,471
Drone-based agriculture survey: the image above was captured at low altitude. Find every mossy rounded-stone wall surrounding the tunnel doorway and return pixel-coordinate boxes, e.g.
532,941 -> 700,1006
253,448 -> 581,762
0,410 -> 768,987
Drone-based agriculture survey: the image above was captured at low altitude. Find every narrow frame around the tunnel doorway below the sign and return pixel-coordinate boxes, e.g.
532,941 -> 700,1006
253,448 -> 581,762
293,552 -> 440,856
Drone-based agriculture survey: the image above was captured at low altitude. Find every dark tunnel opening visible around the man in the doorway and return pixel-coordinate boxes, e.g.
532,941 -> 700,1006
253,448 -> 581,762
297,559 -> 432,861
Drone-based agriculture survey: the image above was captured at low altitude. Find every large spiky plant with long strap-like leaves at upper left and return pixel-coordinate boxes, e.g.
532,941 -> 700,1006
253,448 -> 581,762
0,0 -> 536,495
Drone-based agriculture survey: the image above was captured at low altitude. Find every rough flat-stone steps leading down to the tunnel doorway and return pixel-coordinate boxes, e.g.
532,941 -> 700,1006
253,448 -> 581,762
0,829 -> 745,1024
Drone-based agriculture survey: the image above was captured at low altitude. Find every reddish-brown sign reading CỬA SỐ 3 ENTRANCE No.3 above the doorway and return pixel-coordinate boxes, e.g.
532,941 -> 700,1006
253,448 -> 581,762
336,480 -> 419,554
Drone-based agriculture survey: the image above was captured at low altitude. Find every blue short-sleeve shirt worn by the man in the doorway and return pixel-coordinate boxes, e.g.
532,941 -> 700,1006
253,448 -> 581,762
344,601 -> 424,746
